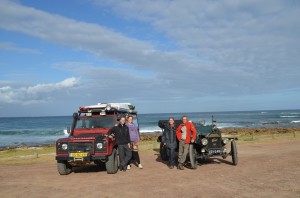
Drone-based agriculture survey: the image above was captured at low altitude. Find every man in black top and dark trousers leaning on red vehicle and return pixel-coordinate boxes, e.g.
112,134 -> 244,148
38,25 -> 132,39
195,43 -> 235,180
108,117 -> 131,171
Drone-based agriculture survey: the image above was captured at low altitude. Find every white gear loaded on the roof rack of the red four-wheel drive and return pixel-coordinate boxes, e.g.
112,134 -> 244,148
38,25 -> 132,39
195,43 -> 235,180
78,103 -> 136,113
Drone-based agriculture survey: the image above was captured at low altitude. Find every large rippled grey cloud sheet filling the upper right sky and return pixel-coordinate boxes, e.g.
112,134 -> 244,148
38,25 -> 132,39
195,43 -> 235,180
94,0 -> 300,94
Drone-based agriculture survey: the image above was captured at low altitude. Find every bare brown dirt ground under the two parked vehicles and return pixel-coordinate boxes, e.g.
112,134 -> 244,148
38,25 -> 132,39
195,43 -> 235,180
0,140 -> 300,198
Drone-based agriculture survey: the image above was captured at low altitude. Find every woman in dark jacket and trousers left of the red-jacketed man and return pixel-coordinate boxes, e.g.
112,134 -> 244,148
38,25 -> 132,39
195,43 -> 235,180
162,117 -> 177,169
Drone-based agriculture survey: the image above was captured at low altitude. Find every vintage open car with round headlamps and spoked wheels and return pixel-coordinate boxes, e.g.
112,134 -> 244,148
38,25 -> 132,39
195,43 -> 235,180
158,116 -> 238,169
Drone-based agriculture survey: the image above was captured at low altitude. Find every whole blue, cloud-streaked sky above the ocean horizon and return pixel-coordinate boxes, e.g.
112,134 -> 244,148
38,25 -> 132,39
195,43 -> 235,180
0,0 -> 300,117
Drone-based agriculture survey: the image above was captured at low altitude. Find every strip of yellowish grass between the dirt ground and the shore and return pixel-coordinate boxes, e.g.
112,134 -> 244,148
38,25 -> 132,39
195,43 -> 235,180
0,132 -> 300,165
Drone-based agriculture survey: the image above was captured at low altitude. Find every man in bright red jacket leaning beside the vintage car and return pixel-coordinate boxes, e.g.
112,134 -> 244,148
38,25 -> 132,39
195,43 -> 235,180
176,116 -> 197,170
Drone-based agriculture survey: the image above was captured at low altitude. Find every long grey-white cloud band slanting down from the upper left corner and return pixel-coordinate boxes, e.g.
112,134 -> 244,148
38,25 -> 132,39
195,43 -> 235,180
0,1 -> 171,71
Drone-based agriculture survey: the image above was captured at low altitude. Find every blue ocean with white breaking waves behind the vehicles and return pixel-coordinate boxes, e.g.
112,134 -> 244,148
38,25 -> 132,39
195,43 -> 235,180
0,110 -> 300,147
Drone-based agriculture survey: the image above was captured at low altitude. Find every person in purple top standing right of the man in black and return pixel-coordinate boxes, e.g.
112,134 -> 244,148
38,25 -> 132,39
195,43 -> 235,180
126,115 -> 143,169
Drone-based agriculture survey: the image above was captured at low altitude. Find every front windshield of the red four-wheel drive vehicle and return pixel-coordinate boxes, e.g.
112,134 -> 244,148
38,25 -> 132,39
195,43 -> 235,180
76,116 -> 114,129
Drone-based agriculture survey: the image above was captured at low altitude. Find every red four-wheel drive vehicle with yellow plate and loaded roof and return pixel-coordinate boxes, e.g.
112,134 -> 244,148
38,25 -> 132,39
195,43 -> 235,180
55,103 -> 139,175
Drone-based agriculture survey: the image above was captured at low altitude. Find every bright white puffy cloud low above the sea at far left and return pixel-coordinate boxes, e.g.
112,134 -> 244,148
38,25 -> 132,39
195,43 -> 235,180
0,77 -> 80,105
